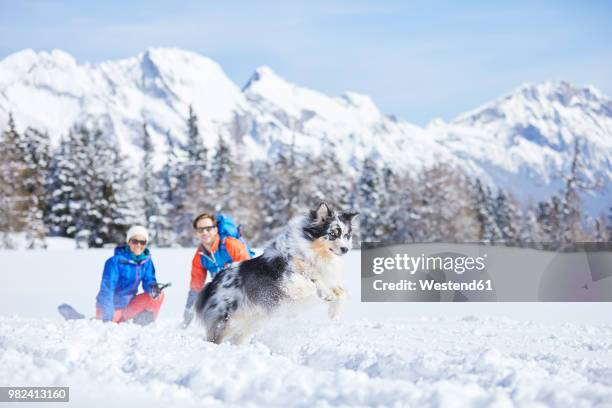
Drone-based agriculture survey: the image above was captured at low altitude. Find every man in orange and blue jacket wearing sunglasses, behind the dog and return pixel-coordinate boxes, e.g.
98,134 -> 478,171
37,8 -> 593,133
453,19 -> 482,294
183,213 -> 251,327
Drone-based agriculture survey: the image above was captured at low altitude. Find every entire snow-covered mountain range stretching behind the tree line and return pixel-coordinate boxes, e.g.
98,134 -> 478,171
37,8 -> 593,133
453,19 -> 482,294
0,48 -> 612,215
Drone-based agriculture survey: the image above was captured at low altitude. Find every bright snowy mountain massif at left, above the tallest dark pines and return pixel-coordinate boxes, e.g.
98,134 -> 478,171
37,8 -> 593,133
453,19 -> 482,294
0,49 -> 247,163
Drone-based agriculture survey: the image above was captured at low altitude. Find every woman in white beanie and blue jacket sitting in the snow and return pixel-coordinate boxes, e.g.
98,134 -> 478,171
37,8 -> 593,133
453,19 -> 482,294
96,225 -> 164,325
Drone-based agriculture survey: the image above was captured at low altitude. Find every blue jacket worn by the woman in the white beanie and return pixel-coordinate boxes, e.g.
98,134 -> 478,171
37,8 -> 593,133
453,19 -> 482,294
96,245 -> 157,322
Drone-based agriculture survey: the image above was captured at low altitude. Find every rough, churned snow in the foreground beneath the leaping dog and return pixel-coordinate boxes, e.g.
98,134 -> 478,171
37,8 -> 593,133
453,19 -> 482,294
0,317 -> 612,407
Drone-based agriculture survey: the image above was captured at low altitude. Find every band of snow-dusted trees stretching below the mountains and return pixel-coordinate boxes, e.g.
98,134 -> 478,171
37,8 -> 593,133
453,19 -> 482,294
0,107 -> 612,249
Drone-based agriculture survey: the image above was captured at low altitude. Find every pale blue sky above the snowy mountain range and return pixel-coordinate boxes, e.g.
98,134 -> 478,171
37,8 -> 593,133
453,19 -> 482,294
0,0 -> 612,125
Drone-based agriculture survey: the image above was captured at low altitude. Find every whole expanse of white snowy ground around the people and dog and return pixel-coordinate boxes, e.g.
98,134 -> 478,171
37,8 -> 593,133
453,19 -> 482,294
0,249 -> 612,407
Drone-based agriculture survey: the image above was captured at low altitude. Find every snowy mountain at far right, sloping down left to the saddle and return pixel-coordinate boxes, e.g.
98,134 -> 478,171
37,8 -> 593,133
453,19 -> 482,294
427,81 -> 612,210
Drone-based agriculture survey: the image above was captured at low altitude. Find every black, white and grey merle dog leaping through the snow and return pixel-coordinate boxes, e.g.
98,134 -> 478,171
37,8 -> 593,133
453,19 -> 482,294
195,202 -> 358,344
